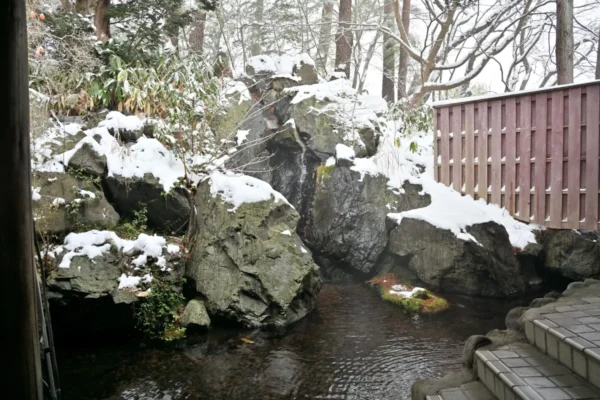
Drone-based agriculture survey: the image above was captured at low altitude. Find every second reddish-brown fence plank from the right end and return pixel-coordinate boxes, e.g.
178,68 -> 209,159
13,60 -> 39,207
567,88 -> 581,226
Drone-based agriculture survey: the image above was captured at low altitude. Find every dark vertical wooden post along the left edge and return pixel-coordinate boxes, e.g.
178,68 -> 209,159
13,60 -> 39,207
0,0 -> 42,400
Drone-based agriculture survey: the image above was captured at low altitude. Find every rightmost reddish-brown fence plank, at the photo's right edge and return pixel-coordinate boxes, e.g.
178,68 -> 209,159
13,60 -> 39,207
585,85 -> 600,230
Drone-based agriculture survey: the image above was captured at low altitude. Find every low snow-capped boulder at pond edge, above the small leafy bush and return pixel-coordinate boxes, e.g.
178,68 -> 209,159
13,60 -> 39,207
48,230 -> 182,305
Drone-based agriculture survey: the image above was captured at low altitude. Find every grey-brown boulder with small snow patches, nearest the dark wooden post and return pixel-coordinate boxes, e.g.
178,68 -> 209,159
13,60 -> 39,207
32,172 -> 119,233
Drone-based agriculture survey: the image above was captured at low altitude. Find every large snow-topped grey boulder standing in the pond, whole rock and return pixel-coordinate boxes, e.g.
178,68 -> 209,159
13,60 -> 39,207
186,172 -> 320,327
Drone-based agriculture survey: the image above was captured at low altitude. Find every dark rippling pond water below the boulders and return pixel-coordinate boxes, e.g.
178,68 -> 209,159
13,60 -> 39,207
59,284 -> 524,400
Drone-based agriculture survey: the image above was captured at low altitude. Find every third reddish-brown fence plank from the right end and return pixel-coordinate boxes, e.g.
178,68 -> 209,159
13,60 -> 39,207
547,90 -> 564,229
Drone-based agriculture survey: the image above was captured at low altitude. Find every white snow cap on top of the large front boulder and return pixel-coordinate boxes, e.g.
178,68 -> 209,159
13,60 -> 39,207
210,171 -> 291,212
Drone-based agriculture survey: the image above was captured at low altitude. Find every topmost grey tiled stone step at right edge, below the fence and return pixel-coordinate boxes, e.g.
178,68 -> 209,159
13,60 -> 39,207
525,297 -> 600,388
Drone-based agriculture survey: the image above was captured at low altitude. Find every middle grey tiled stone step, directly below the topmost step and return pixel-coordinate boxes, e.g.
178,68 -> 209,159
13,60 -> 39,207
475,343 -> 600,400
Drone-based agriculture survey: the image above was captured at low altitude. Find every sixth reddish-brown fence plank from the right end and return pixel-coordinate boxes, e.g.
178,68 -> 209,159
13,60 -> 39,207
504,97 -> 517,215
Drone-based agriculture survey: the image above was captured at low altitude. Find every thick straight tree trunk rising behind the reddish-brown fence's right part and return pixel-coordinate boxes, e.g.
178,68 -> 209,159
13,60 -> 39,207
556,0 -> 573,85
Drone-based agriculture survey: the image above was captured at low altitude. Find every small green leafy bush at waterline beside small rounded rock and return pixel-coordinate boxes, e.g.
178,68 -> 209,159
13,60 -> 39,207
135,277 -> 185,340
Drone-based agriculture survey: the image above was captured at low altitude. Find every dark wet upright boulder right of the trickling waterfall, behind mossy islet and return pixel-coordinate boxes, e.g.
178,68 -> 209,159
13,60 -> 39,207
300,152 -> 430,274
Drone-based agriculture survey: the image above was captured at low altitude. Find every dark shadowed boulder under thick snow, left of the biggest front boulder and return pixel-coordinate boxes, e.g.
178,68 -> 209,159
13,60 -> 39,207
105,174 -> 190,233
